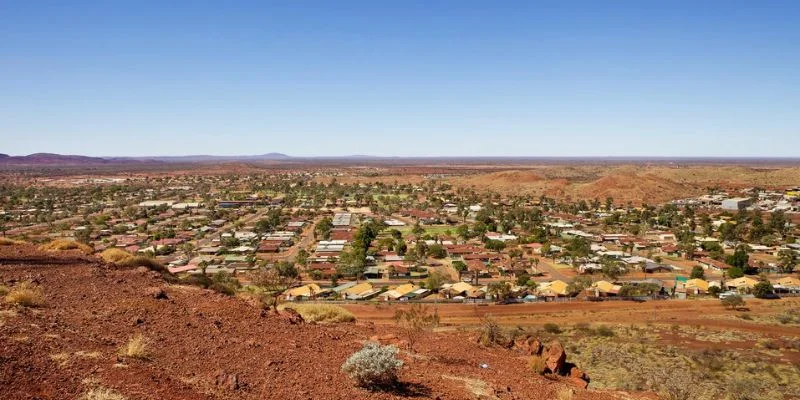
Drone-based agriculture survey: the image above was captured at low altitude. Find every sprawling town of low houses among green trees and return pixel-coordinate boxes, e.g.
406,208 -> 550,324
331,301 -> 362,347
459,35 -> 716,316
0,172 -> 800,303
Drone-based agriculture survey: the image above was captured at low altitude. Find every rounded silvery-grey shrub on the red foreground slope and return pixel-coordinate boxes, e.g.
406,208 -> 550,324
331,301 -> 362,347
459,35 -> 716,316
342,342 -> 403,387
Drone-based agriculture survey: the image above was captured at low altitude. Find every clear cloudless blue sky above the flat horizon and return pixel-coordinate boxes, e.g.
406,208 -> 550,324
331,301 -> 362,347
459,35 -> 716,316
0,0 -> 800,156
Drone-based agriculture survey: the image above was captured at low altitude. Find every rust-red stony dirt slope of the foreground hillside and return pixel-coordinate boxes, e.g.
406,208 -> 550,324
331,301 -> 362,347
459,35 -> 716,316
0,246 -> 636,400
